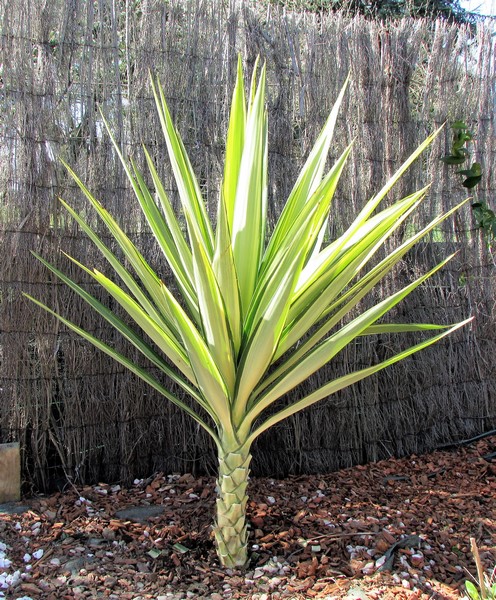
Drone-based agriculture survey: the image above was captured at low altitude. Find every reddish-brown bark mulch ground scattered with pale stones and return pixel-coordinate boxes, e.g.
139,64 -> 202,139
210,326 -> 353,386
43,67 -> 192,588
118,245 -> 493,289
0,435 -> 496,600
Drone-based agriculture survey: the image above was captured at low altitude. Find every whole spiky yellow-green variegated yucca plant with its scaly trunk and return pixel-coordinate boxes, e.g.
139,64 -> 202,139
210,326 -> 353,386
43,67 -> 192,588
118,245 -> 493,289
25,61 -> 470,567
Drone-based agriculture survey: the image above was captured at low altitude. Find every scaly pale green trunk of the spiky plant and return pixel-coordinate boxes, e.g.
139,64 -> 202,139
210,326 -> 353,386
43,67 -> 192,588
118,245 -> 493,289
214,447 -> 251,568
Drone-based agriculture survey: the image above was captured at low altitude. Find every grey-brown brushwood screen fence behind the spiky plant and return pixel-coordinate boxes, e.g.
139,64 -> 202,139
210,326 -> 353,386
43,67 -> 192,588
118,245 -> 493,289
0,0 -> 496,489
